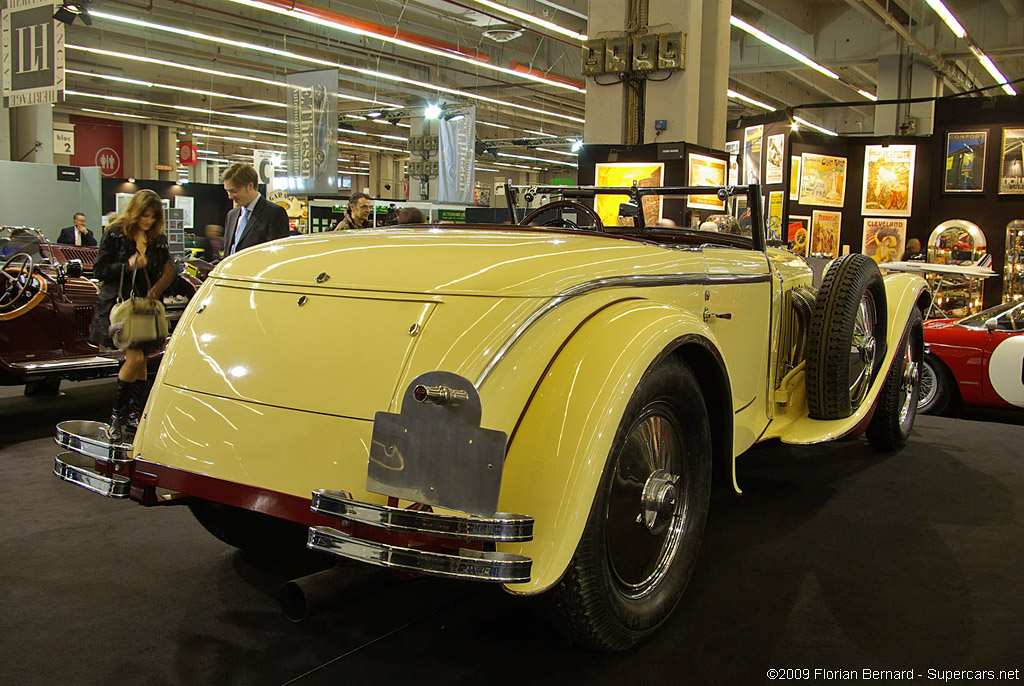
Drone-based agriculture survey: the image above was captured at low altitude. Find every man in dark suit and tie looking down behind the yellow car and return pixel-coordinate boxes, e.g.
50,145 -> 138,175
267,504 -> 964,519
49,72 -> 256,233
221,162 -> 288,257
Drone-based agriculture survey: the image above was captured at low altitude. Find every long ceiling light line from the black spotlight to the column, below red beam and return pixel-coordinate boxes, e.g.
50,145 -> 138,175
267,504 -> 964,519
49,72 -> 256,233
92,11 -> 586,124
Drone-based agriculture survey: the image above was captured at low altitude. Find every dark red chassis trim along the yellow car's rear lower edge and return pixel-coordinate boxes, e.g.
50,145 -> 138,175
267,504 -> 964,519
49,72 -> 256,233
102,458 -> 484,551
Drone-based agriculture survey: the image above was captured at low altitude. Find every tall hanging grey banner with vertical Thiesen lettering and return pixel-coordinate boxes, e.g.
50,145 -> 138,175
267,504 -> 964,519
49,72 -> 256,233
285,69 -> 338,196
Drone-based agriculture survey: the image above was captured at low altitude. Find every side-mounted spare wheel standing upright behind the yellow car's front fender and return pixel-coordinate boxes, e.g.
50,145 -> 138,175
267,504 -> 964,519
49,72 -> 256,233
806,254 -> 886,420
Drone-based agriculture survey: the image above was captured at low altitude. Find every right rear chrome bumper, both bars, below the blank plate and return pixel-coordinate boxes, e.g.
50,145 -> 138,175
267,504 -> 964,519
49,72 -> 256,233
306,490 -> 534,584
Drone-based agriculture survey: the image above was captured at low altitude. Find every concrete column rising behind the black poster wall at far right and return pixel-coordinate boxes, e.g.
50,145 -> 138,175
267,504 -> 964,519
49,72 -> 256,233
874,54 -> 942,136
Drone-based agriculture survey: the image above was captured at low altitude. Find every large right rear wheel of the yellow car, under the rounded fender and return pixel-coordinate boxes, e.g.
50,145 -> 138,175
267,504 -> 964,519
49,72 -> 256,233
546,358 -> 712,651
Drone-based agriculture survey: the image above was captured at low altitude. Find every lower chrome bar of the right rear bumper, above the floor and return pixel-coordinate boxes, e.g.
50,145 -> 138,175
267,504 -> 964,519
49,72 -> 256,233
306,526 -> 532,584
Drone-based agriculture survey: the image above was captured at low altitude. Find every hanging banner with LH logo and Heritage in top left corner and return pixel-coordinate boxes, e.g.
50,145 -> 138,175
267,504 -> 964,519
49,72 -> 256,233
0,0 -> 65,108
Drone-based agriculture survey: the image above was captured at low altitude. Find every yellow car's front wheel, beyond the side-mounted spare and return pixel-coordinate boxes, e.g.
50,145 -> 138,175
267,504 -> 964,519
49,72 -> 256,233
866,307 -> 925,453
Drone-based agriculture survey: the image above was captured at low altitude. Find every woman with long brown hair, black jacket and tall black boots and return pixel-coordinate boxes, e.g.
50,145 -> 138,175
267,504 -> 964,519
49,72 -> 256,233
89,190 -> 175,443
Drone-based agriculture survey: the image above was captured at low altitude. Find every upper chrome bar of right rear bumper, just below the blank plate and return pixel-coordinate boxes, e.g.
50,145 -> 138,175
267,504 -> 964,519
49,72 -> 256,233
310,490 -> 534,543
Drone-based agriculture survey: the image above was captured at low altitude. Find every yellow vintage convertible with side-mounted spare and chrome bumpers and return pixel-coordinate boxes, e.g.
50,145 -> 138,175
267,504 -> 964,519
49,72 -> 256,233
54,186 -> 930,650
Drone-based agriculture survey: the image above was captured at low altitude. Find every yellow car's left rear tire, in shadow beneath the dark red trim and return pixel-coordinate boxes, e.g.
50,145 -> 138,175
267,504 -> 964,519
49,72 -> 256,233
188,500 -> 309,554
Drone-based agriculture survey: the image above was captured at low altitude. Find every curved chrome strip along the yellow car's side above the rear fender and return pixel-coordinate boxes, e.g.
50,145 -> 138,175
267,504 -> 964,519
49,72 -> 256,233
474,273 -> 771,390
